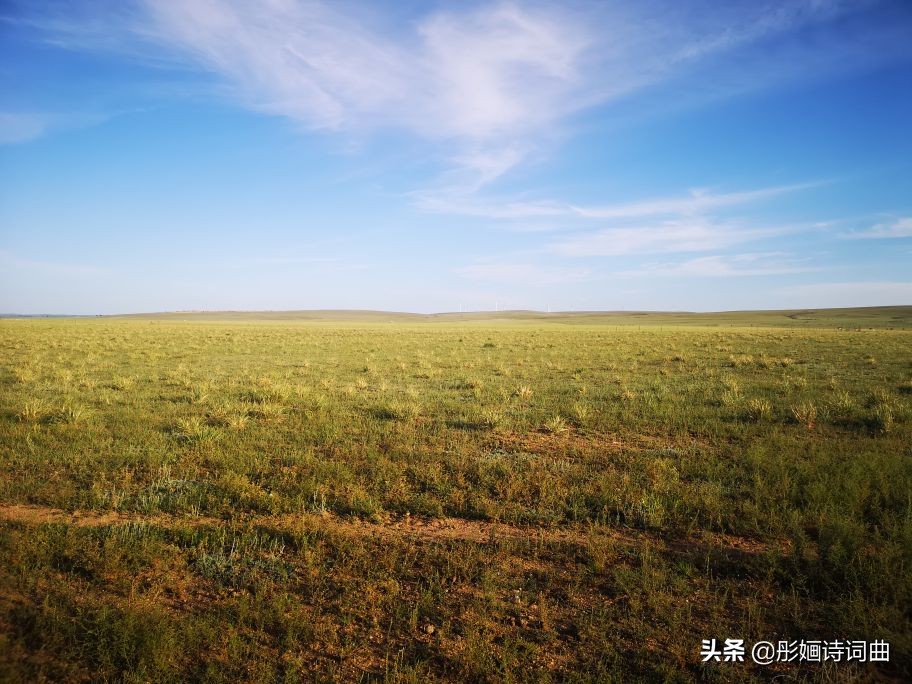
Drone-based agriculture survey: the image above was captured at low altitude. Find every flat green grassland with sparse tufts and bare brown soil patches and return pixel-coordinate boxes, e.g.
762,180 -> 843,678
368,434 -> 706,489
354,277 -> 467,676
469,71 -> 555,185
0,307 -> 912,682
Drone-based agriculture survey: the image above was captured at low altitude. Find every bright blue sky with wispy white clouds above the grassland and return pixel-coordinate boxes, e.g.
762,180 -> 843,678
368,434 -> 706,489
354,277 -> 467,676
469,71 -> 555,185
0,0 -> 912,314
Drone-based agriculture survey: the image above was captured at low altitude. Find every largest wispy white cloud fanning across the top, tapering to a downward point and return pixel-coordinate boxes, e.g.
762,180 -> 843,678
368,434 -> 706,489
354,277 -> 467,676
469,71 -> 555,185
15,0 -> 881,184
